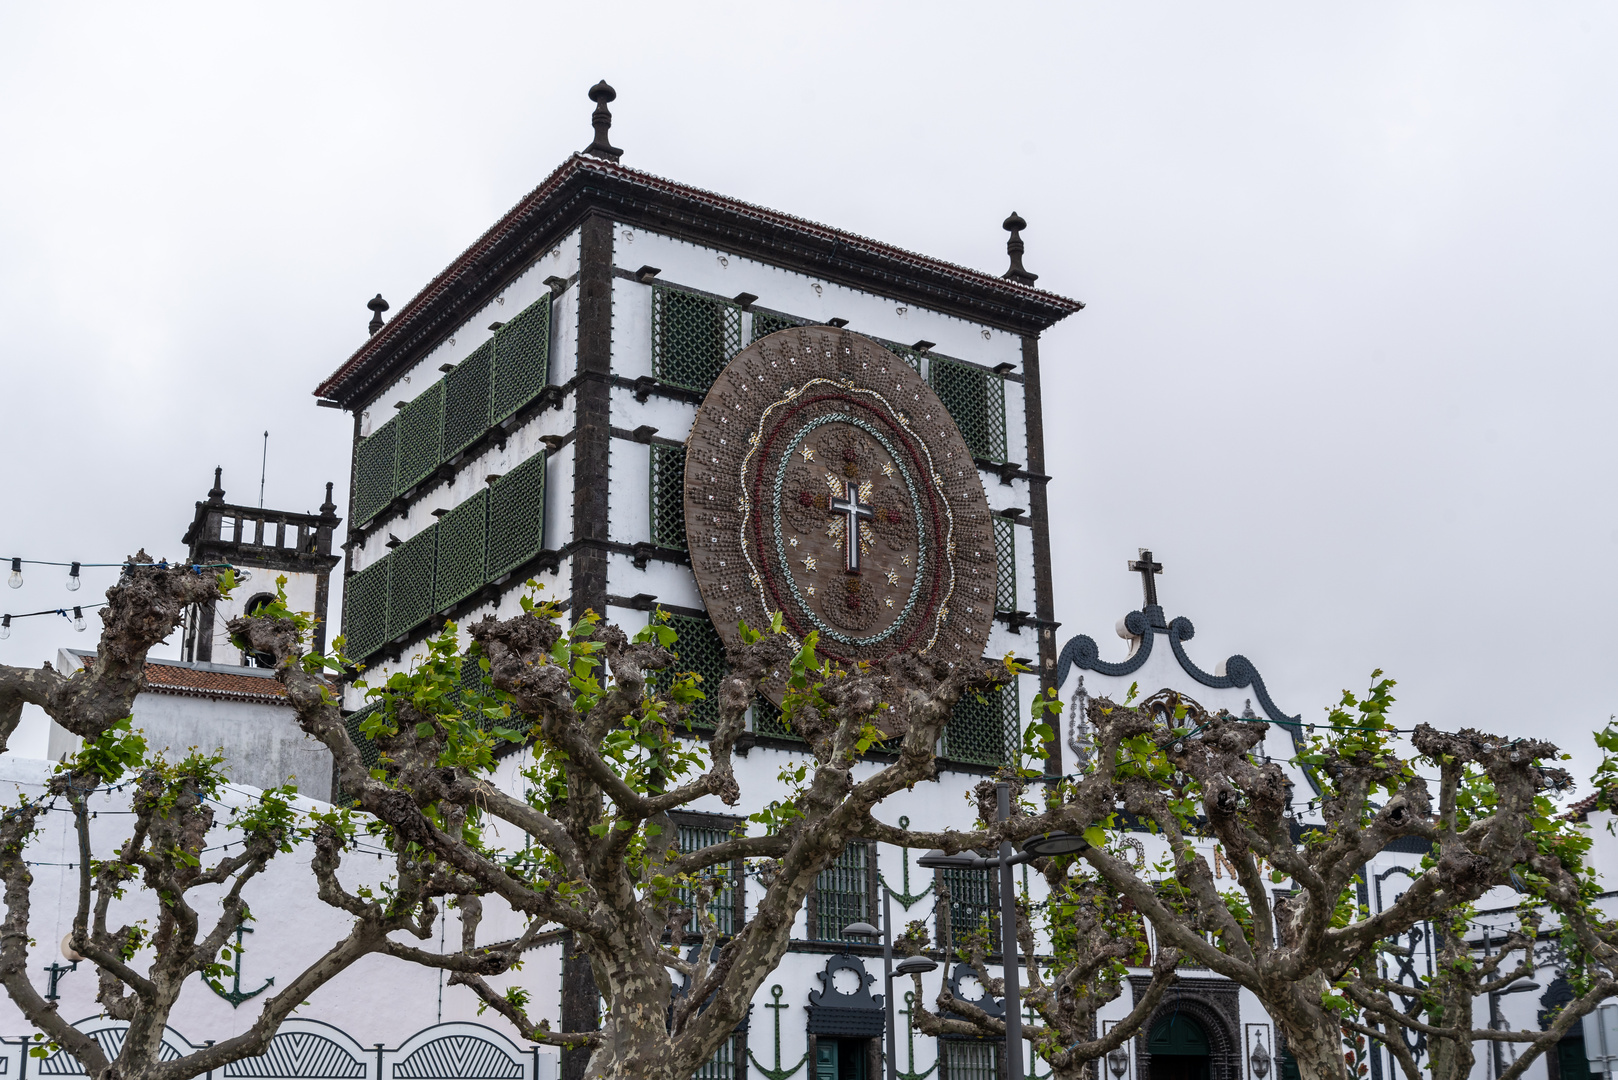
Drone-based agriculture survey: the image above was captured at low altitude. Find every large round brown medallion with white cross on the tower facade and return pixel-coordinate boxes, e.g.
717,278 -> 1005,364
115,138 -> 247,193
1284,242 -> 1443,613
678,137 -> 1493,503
684,327 -> 995,696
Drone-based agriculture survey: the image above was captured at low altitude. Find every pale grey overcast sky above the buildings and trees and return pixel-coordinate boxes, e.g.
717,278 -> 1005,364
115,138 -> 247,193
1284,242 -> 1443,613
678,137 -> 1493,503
0,2 -> 1618,786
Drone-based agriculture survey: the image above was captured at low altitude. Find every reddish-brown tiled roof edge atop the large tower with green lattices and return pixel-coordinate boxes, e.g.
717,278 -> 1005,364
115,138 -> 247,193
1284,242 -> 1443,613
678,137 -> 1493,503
316,154 -> 1084,397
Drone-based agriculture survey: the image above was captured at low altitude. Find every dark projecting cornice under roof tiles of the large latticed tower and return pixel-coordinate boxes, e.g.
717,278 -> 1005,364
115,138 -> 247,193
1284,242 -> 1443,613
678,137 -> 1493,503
316,154 -> 1084,408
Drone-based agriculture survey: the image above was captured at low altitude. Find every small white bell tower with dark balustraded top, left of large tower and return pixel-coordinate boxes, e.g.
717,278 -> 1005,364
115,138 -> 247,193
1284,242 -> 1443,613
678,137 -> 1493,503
181,468 -> 341,667
